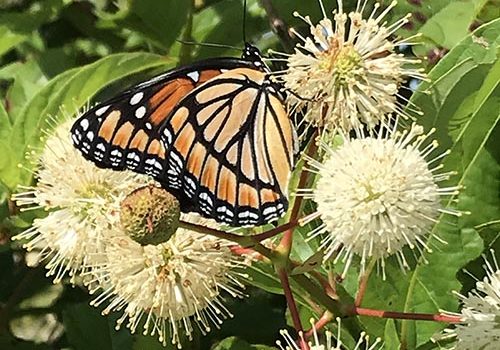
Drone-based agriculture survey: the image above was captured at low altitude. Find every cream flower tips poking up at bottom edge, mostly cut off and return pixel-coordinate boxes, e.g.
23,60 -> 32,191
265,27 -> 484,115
276,318 -> 384,350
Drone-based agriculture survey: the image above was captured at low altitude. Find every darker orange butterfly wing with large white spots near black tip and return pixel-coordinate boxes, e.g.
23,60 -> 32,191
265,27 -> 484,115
71,58 -> 254,178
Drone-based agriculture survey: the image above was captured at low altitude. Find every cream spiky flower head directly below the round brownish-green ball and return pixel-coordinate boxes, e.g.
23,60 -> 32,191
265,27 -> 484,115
91,215 -> 248,348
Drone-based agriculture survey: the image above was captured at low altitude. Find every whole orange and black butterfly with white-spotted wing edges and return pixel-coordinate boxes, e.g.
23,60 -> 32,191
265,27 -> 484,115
71,44 -> 295,226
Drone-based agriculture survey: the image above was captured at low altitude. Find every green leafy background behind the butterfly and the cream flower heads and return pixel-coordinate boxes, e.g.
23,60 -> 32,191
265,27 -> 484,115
0,0 -> 500,350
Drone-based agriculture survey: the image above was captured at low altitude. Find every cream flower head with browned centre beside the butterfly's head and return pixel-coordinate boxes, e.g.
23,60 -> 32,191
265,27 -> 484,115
282,0 -> 424,132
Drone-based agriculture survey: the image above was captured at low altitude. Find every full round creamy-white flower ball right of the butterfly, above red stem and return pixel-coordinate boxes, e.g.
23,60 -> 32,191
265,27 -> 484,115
305,125 -> 460,277
